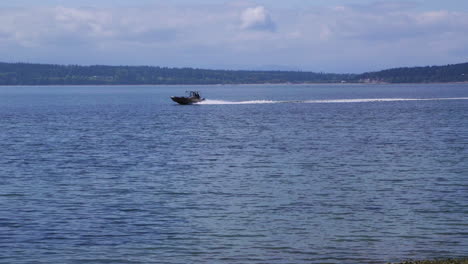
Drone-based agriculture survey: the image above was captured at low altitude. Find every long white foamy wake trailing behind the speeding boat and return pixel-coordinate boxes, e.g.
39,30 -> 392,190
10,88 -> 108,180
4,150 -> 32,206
197,97 -> 468,105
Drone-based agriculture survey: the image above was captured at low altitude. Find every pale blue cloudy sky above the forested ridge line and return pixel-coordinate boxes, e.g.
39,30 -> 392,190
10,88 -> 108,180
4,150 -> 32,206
0,0 -> 468,73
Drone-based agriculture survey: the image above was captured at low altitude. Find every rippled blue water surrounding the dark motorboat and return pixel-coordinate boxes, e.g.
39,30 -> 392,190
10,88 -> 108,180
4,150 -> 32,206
0,84 -> 468,264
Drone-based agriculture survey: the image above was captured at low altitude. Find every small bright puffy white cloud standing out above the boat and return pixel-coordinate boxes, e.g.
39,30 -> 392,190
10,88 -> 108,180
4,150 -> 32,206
241,6 -> 276,31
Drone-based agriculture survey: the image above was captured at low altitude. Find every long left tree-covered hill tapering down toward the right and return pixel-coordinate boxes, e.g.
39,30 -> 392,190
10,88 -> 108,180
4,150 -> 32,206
0,63 -> 355,85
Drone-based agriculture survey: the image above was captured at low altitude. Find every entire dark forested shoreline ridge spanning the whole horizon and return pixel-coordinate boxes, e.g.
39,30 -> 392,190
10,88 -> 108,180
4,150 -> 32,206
0,60 -> 468,85
